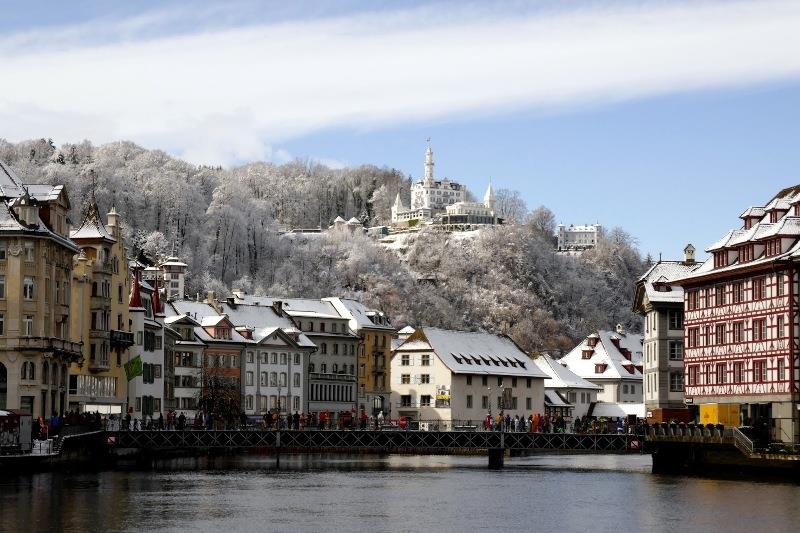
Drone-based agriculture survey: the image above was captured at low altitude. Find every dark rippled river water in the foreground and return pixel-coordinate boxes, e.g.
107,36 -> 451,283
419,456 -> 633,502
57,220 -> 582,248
0,455 -> 800,533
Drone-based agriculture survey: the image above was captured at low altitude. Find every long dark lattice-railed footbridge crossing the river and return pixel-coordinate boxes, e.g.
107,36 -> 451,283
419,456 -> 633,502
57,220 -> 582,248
106,429 -> 642,468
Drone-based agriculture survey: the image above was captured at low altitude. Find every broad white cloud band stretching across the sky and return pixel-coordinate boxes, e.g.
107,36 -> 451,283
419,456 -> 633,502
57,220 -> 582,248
0,0 -> 800,164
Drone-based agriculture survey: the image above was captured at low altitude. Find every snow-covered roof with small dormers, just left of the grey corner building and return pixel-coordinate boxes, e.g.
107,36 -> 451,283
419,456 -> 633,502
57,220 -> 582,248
560,330 -> 642,381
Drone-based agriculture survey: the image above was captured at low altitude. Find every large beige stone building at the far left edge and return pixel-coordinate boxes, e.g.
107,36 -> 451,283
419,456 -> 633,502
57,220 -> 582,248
0,161 -> 81,417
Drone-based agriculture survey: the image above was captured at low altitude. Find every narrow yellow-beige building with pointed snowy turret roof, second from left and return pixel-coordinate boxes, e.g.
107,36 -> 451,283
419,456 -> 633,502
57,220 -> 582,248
69,203 -> 134,414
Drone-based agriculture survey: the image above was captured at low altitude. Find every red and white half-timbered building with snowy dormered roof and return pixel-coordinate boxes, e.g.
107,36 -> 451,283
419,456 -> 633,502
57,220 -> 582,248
679,187 -> 800,442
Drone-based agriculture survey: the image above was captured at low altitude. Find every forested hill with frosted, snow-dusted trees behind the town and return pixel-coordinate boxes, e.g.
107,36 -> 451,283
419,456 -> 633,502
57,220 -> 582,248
0,139 -> 646,349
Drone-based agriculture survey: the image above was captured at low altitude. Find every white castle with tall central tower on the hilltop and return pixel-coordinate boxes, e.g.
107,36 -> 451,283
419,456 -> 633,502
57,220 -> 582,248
392,145 -> 502,226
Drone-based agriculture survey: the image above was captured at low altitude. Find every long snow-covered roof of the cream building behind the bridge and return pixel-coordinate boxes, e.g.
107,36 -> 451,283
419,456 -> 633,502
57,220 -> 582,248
397,328 -> 547,378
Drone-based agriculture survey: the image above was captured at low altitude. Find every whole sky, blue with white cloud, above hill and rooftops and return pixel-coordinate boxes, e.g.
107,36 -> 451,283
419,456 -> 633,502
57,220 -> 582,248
0,0 -> 800,259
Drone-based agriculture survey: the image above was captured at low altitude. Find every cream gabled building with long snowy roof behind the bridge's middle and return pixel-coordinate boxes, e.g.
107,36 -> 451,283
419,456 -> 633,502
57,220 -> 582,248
391,328 -> 548,425
